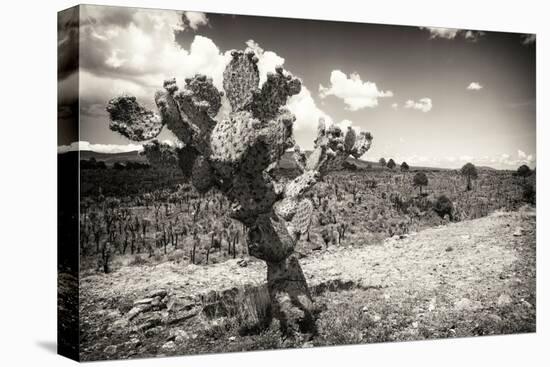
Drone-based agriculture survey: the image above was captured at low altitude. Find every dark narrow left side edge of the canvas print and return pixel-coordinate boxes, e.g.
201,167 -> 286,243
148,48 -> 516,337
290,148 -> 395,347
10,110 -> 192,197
57,6 -> 80,361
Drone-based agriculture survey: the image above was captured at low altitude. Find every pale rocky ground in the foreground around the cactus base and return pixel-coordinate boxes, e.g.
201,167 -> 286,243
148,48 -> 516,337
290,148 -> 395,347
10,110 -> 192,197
80,207 -> 536,360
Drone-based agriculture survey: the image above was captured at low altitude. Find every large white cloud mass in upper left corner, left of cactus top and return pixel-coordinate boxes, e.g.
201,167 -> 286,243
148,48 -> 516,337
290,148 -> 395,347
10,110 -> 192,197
80,6 -> 231,98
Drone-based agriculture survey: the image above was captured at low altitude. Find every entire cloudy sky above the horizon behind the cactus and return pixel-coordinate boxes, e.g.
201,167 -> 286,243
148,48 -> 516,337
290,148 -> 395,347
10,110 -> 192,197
58,5 -> 536,169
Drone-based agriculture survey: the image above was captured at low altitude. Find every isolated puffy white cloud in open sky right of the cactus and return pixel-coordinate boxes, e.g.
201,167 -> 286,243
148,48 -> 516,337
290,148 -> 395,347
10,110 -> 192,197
319,70 -> 393,111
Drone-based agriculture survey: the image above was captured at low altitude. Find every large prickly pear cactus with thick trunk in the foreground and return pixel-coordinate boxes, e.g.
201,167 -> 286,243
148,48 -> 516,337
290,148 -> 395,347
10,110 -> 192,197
107,49 -> 372,336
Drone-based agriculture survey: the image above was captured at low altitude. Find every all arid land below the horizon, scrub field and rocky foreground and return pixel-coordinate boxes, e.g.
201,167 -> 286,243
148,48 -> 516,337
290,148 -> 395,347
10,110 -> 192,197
68,153 -> 536,360
